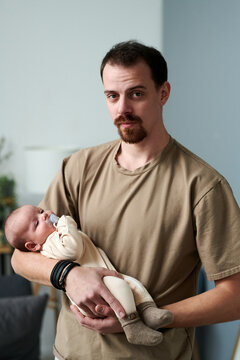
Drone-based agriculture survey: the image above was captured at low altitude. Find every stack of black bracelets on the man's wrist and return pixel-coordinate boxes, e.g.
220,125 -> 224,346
50,260 -> 80,291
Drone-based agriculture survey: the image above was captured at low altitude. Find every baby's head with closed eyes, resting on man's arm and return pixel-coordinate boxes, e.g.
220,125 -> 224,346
5,205 -> 56,251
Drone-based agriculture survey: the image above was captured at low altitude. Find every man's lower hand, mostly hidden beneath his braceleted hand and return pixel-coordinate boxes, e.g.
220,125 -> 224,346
71,305 -> 123,335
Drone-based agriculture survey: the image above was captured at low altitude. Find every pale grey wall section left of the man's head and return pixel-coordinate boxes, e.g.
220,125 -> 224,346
0,0 -> 162,197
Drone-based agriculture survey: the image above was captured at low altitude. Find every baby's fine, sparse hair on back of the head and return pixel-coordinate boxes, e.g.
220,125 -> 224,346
4,207 -> 29,251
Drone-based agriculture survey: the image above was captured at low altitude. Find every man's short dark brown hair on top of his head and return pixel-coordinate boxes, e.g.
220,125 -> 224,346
100,40 -> 168,87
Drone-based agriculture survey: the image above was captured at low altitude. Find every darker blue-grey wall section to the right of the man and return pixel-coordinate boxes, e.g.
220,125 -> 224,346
163,0 -> 240,360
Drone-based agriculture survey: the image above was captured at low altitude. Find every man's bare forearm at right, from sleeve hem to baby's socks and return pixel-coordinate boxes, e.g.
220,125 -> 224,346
163,273 -> 240,327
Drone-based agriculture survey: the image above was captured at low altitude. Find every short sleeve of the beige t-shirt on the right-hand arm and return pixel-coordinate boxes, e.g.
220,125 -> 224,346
194,179 -> 240,280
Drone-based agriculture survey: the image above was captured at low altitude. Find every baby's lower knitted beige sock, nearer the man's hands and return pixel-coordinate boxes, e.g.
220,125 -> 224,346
119,313 -> 163,346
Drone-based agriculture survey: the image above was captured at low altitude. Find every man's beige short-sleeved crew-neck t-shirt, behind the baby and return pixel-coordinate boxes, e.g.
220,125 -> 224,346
41,139 -> 240,360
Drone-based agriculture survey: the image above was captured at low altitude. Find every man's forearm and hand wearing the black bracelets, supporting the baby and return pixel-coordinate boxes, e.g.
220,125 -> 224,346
12,250 -> 125,321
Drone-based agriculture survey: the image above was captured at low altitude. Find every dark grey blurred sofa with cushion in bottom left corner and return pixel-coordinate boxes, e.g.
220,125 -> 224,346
0,274 -> 48,360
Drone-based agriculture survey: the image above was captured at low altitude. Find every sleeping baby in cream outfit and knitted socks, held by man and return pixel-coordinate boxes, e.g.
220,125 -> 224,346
5,205 -> 173,346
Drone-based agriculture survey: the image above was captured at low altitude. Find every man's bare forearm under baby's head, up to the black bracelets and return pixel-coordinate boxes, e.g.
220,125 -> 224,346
11,250 -> 58,286
